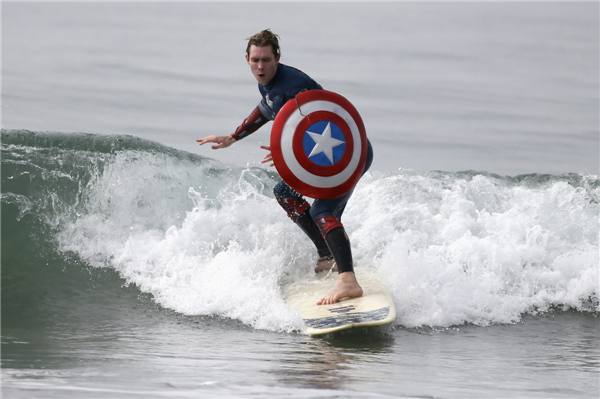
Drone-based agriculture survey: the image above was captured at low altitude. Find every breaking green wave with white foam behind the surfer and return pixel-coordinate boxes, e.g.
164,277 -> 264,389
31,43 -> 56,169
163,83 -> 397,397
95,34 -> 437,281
2,131 -> 600,331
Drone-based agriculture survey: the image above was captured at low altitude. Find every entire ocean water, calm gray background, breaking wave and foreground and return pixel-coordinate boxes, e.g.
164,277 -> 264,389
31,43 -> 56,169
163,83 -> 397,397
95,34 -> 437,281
1,3 -> 600,398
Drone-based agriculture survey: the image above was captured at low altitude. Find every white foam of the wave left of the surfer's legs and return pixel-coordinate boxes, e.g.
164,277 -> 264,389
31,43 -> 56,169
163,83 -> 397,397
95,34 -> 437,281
60,154 -> 311,331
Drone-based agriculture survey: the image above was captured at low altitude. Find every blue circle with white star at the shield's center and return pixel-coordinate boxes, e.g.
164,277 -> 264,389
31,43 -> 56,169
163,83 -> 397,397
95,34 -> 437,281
302,121 -> 346,166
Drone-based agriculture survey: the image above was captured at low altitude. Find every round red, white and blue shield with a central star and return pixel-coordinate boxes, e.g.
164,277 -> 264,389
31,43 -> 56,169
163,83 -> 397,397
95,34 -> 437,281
271,90 -> 367,199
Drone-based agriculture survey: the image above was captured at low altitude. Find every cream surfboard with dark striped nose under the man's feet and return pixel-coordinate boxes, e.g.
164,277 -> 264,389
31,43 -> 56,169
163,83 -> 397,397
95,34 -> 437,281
285,270 -> 396,335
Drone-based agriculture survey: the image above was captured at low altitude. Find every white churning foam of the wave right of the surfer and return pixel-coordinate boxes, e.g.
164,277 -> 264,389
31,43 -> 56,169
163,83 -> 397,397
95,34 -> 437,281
346,171 -> 599,327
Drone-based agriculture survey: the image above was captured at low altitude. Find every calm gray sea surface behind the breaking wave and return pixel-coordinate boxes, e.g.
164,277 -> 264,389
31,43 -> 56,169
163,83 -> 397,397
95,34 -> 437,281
2,2 -> 600,176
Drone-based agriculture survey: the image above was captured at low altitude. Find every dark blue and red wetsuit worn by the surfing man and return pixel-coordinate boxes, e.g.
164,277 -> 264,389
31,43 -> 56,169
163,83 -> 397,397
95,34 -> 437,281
233,64 -> 373,273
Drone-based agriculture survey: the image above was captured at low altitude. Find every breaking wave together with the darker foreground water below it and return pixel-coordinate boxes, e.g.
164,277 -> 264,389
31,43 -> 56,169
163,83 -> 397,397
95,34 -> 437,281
2,131 -> 600,398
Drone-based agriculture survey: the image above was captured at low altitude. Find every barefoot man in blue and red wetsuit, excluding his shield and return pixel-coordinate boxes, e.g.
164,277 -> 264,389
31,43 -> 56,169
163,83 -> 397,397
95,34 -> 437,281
196,29 -> 373,305
